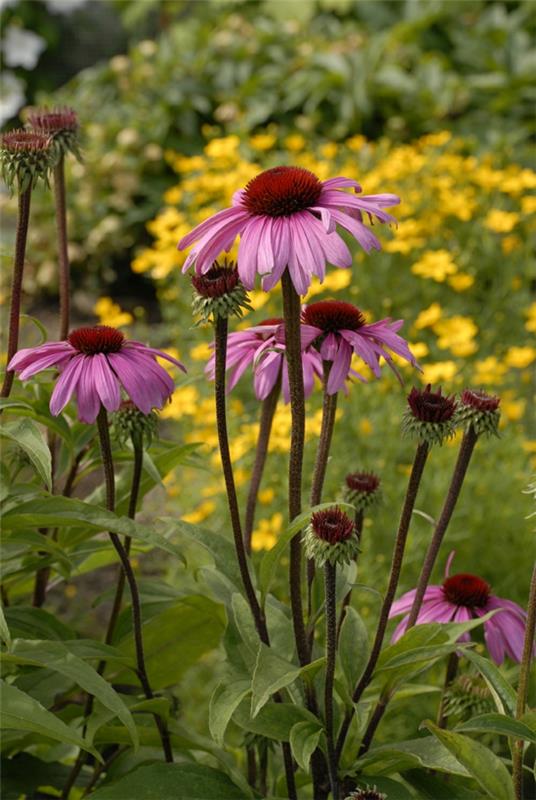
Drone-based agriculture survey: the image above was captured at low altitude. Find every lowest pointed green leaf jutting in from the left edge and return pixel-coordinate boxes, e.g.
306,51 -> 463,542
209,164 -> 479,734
0,681 -> 102,762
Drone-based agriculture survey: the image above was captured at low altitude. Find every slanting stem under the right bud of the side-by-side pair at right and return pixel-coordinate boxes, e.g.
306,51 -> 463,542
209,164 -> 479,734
406,425 -> 478,631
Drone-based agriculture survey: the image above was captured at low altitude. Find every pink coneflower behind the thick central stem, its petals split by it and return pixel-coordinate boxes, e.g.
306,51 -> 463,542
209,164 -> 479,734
205,318 -> 322,403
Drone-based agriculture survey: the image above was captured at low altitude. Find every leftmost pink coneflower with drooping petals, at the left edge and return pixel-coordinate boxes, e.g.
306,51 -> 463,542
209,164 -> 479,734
8,325 -> 186,423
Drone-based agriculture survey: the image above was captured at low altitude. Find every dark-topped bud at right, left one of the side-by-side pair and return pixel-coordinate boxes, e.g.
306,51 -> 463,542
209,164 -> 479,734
402,383 -> 457,447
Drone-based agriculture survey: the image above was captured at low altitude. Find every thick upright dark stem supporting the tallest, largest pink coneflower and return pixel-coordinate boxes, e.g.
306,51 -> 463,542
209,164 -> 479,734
281,269 -> 310,666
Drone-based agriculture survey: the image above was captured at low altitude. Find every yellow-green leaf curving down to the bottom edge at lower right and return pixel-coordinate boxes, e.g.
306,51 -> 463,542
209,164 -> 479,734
424,722 -> 514,800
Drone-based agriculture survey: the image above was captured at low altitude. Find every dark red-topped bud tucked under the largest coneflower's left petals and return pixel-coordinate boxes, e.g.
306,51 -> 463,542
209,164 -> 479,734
192,260 -> 253,322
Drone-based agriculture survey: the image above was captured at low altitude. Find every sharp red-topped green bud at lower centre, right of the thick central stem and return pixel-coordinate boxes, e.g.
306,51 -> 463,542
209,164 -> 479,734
303,506 -> 359,567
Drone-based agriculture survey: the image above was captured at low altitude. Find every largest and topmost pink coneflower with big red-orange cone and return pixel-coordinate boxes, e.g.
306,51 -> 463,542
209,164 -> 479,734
178,167 -> 400,295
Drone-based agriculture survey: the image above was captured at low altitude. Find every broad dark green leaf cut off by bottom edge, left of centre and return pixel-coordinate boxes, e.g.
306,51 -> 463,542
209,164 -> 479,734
91,763 -> 248,800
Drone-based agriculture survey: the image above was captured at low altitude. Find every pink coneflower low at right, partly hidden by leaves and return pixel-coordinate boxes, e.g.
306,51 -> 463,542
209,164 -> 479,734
389,553 -> 527,664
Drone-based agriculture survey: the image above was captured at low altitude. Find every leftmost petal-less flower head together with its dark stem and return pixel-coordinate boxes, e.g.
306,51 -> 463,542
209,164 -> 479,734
0,130 -> 52,397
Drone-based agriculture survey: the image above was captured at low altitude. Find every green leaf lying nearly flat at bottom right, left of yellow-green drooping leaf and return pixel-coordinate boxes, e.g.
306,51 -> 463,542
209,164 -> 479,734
357,737 -> 468,777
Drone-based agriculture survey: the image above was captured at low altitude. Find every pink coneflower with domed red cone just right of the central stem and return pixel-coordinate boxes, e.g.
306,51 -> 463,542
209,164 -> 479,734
302,300 -> 420,394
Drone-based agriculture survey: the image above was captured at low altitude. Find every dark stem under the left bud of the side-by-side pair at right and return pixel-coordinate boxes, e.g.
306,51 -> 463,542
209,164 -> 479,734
337,442 -> 429,757
